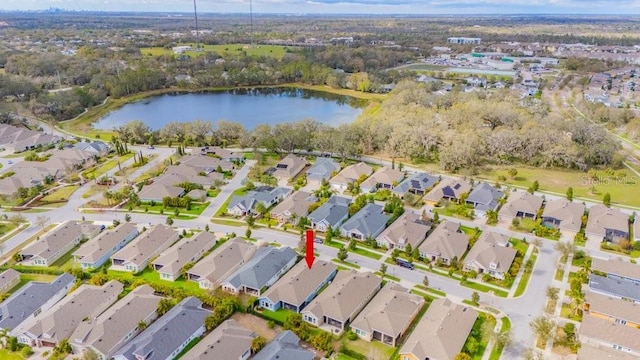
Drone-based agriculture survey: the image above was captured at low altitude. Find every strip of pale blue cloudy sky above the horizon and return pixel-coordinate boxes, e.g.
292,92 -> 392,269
0,0 -> 640,14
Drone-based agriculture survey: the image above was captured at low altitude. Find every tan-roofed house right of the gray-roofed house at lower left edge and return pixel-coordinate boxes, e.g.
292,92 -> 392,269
18,280 -> 124,347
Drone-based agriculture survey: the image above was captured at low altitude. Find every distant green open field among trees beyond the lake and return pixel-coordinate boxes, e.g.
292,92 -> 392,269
140,44 -> 296,60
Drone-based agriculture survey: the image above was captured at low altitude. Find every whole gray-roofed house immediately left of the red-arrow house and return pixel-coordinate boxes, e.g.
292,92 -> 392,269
221,246 -> 298,296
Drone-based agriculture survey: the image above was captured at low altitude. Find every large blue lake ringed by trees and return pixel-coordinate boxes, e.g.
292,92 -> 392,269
94,88 -> 366,130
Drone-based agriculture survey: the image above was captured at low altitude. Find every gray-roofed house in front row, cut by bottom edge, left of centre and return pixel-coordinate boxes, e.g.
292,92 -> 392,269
113,296 -> 211,360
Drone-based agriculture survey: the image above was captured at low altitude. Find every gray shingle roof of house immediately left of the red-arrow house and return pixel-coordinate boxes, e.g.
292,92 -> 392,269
224,247 -> 297,290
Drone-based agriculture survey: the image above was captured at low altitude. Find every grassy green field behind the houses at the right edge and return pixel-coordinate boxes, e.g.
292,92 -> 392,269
476,167 -> 640,207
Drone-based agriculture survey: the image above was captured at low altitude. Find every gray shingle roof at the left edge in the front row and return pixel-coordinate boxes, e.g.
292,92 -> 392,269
0,273 -> 76,330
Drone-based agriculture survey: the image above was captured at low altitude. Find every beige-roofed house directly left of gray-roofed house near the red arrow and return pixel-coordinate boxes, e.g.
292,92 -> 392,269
187,238 -> 257,290
